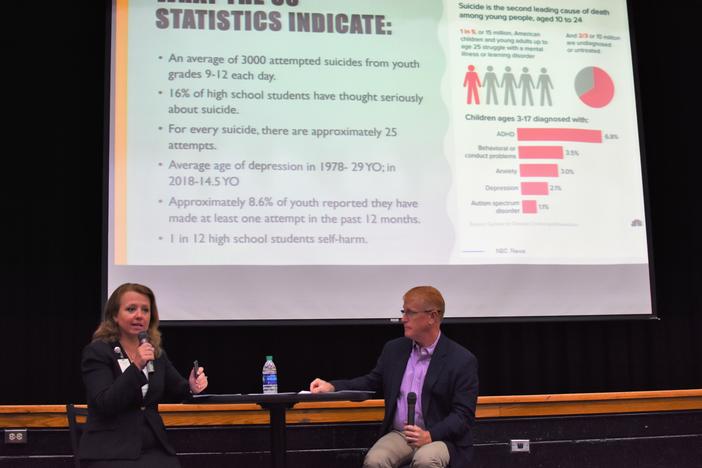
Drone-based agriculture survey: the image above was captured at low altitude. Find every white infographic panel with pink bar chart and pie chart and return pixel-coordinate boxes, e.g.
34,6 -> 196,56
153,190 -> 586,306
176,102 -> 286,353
444,1 -> 646,264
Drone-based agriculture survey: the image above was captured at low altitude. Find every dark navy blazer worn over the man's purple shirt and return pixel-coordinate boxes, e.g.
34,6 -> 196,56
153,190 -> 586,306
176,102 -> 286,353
330,333 -> 478,468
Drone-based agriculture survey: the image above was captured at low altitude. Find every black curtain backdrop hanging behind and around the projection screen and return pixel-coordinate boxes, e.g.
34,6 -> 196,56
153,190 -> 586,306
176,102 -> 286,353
0,1 -> 702,404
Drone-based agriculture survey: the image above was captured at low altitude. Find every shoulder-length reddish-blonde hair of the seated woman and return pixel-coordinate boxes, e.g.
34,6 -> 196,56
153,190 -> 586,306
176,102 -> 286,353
93,283 -> 161,357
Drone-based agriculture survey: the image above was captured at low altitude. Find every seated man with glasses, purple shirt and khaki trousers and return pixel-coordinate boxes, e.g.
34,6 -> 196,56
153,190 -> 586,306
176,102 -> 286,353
310,286 -> 478,468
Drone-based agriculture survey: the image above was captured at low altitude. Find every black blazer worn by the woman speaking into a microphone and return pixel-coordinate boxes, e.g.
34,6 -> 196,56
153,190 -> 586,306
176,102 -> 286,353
78,341 -> 190,460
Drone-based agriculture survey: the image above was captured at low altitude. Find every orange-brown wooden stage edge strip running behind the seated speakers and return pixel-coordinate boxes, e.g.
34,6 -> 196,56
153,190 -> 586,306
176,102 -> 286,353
0,389 -> 702,428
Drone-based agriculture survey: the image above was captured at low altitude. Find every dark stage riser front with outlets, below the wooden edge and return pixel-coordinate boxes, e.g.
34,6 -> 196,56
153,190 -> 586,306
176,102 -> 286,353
0,411 -> 702,468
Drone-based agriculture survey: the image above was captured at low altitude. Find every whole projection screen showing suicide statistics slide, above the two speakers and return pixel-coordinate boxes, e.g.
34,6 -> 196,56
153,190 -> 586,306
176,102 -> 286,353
107,0 -> 652,321
